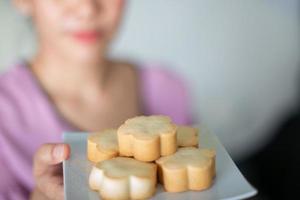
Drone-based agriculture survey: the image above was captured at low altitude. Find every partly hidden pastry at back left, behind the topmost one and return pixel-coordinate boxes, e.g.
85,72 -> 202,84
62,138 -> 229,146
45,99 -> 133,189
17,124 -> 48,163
87,129 -> 119,163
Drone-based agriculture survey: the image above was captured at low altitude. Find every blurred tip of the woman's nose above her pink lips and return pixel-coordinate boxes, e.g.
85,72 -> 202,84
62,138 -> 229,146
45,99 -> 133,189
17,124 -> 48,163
78,0 -> 99,19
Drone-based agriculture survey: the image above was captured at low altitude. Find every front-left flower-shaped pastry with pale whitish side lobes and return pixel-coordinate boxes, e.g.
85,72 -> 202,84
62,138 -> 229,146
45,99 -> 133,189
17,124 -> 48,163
89,157 -> 157,200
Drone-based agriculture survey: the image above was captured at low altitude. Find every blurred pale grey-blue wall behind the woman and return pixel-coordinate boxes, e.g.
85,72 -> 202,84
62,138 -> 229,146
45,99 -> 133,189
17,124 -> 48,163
0,0 -> 300,160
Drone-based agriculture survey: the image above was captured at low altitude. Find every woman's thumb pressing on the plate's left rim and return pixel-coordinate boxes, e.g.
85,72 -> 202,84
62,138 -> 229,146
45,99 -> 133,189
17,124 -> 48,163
33,144 -> 70,177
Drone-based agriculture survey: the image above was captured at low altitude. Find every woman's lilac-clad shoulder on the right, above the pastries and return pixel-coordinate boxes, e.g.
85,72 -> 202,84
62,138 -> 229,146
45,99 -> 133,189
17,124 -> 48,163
139,63 -> 193,124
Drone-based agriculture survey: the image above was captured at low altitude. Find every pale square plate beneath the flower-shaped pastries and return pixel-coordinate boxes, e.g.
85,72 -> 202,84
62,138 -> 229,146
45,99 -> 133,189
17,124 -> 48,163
63,127 -> 257,200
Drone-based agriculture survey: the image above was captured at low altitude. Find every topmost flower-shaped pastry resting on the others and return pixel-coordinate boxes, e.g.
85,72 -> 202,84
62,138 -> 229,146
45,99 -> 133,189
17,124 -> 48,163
118,115 -> 177,162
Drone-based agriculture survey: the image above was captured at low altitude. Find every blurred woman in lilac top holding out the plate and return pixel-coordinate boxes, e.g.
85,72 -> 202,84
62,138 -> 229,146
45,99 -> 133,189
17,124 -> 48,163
0,0 -> 195,200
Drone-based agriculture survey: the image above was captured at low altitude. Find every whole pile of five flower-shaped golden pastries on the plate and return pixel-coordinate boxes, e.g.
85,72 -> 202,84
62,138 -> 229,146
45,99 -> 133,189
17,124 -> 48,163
87,115 -> 216,199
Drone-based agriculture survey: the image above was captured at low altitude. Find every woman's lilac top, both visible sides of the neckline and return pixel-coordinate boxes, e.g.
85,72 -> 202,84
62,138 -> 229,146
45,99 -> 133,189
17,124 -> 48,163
0,63 -> 192,200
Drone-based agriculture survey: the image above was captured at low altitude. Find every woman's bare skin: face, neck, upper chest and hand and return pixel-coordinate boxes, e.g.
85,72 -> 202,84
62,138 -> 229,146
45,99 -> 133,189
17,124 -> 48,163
14,0 -> 140,200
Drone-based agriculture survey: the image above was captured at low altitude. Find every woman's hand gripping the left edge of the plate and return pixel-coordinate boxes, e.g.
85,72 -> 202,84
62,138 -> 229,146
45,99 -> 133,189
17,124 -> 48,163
31,144 -> 70,200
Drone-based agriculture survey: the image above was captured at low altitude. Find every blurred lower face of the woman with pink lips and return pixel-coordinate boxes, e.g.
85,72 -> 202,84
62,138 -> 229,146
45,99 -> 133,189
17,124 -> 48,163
16,0 -> 124,62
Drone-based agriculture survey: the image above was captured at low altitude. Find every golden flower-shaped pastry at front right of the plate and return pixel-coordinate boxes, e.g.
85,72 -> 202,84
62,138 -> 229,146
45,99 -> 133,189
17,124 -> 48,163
156,147 -> 215,192
